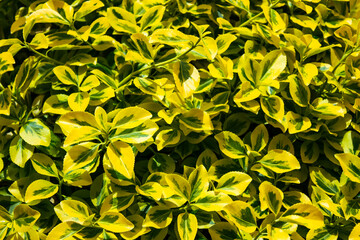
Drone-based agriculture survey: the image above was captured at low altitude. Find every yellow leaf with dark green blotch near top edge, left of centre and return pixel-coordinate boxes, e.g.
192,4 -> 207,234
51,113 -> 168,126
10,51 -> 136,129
107,7 -> 140,34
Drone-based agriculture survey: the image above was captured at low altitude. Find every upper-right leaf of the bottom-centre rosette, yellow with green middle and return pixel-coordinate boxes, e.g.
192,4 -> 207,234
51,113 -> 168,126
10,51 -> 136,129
216,172 -> 252,196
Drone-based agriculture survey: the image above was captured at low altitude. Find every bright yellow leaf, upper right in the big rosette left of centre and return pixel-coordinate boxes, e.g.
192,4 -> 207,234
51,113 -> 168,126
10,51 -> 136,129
112,107 -> 152,129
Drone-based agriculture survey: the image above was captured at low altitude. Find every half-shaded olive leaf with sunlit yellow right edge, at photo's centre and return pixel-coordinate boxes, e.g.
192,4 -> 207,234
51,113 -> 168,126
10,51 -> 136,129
179,108 -> 214,131
